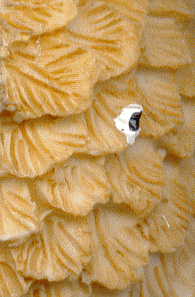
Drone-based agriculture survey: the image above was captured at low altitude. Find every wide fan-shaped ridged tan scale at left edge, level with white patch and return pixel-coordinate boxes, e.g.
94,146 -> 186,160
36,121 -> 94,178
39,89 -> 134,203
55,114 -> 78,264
0,115 -> 86,178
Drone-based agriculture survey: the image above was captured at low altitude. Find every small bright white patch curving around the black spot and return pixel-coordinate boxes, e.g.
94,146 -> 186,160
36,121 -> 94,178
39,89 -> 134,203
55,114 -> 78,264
114,104 -> 143,144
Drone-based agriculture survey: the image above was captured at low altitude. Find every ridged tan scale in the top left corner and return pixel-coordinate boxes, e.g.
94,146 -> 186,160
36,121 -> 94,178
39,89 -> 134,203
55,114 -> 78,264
0,0 -> 77,46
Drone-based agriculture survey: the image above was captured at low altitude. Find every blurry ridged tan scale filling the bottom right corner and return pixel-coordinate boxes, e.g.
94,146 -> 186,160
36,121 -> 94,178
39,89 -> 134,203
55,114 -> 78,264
141,221 -> 195,297
